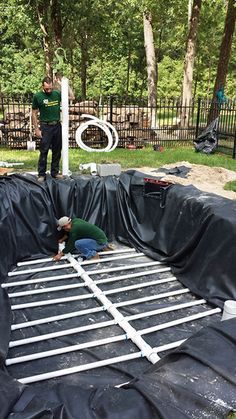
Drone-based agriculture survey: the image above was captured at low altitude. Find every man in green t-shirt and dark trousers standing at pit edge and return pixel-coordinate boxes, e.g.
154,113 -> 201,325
32,77 -> 63,182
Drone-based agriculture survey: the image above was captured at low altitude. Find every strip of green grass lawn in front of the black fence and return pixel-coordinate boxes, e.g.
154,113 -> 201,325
0,147 -> 236,190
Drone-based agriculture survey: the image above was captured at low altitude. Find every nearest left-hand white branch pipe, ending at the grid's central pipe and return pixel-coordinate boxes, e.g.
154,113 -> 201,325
18,351 -> 144,384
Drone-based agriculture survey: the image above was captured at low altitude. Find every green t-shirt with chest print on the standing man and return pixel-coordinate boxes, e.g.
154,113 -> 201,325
32,90 -> 61,122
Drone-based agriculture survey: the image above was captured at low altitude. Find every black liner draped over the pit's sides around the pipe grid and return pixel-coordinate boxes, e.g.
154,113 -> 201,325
0,171 -> 236,419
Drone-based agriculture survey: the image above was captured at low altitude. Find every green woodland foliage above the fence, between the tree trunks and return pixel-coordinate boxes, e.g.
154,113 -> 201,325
0,0 -> 236,98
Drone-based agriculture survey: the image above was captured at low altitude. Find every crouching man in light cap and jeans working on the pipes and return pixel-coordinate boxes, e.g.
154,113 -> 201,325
53,216 -> 108,261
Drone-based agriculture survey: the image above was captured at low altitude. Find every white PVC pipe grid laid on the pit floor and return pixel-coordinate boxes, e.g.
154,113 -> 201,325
2,248 -> 221,384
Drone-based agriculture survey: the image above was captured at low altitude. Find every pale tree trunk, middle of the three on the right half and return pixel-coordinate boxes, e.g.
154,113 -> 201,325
180,0 -> 201,127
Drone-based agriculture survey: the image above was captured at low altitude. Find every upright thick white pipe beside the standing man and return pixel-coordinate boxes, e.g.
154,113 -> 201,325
61,77 -> 69,176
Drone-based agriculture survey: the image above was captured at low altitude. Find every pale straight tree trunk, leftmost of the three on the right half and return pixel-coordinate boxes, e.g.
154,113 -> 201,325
143,12 -> 157,120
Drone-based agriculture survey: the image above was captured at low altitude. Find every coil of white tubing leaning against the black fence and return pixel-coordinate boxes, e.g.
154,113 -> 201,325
75,114 -> 119,153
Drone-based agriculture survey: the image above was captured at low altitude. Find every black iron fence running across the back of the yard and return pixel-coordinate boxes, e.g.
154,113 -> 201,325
0,95 -> 236,158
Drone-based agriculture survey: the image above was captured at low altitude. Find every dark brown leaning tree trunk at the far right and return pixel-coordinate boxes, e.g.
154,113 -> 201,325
208,0 -> 236,124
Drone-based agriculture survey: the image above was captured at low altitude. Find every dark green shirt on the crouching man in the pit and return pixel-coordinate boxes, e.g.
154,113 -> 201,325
63,218 -> 108,253
